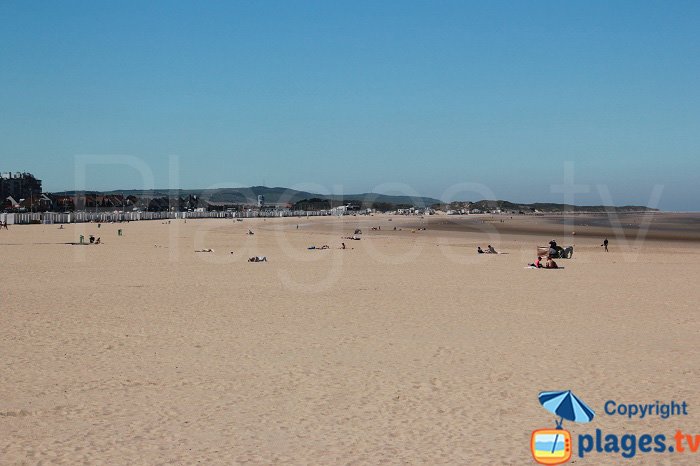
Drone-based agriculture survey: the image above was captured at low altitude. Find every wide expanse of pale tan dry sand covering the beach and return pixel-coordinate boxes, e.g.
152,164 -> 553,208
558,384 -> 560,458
0,216 -> 700,465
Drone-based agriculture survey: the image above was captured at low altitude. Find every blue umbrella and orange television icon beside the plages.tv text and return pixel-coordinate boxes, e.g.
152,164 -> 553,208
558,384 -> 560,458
530,390 -> 595,464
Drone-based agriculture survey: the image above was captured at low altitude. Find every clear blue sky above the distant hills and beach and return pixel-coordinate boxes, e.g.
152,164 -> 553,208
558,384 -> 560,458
0,0 -> 700,210
